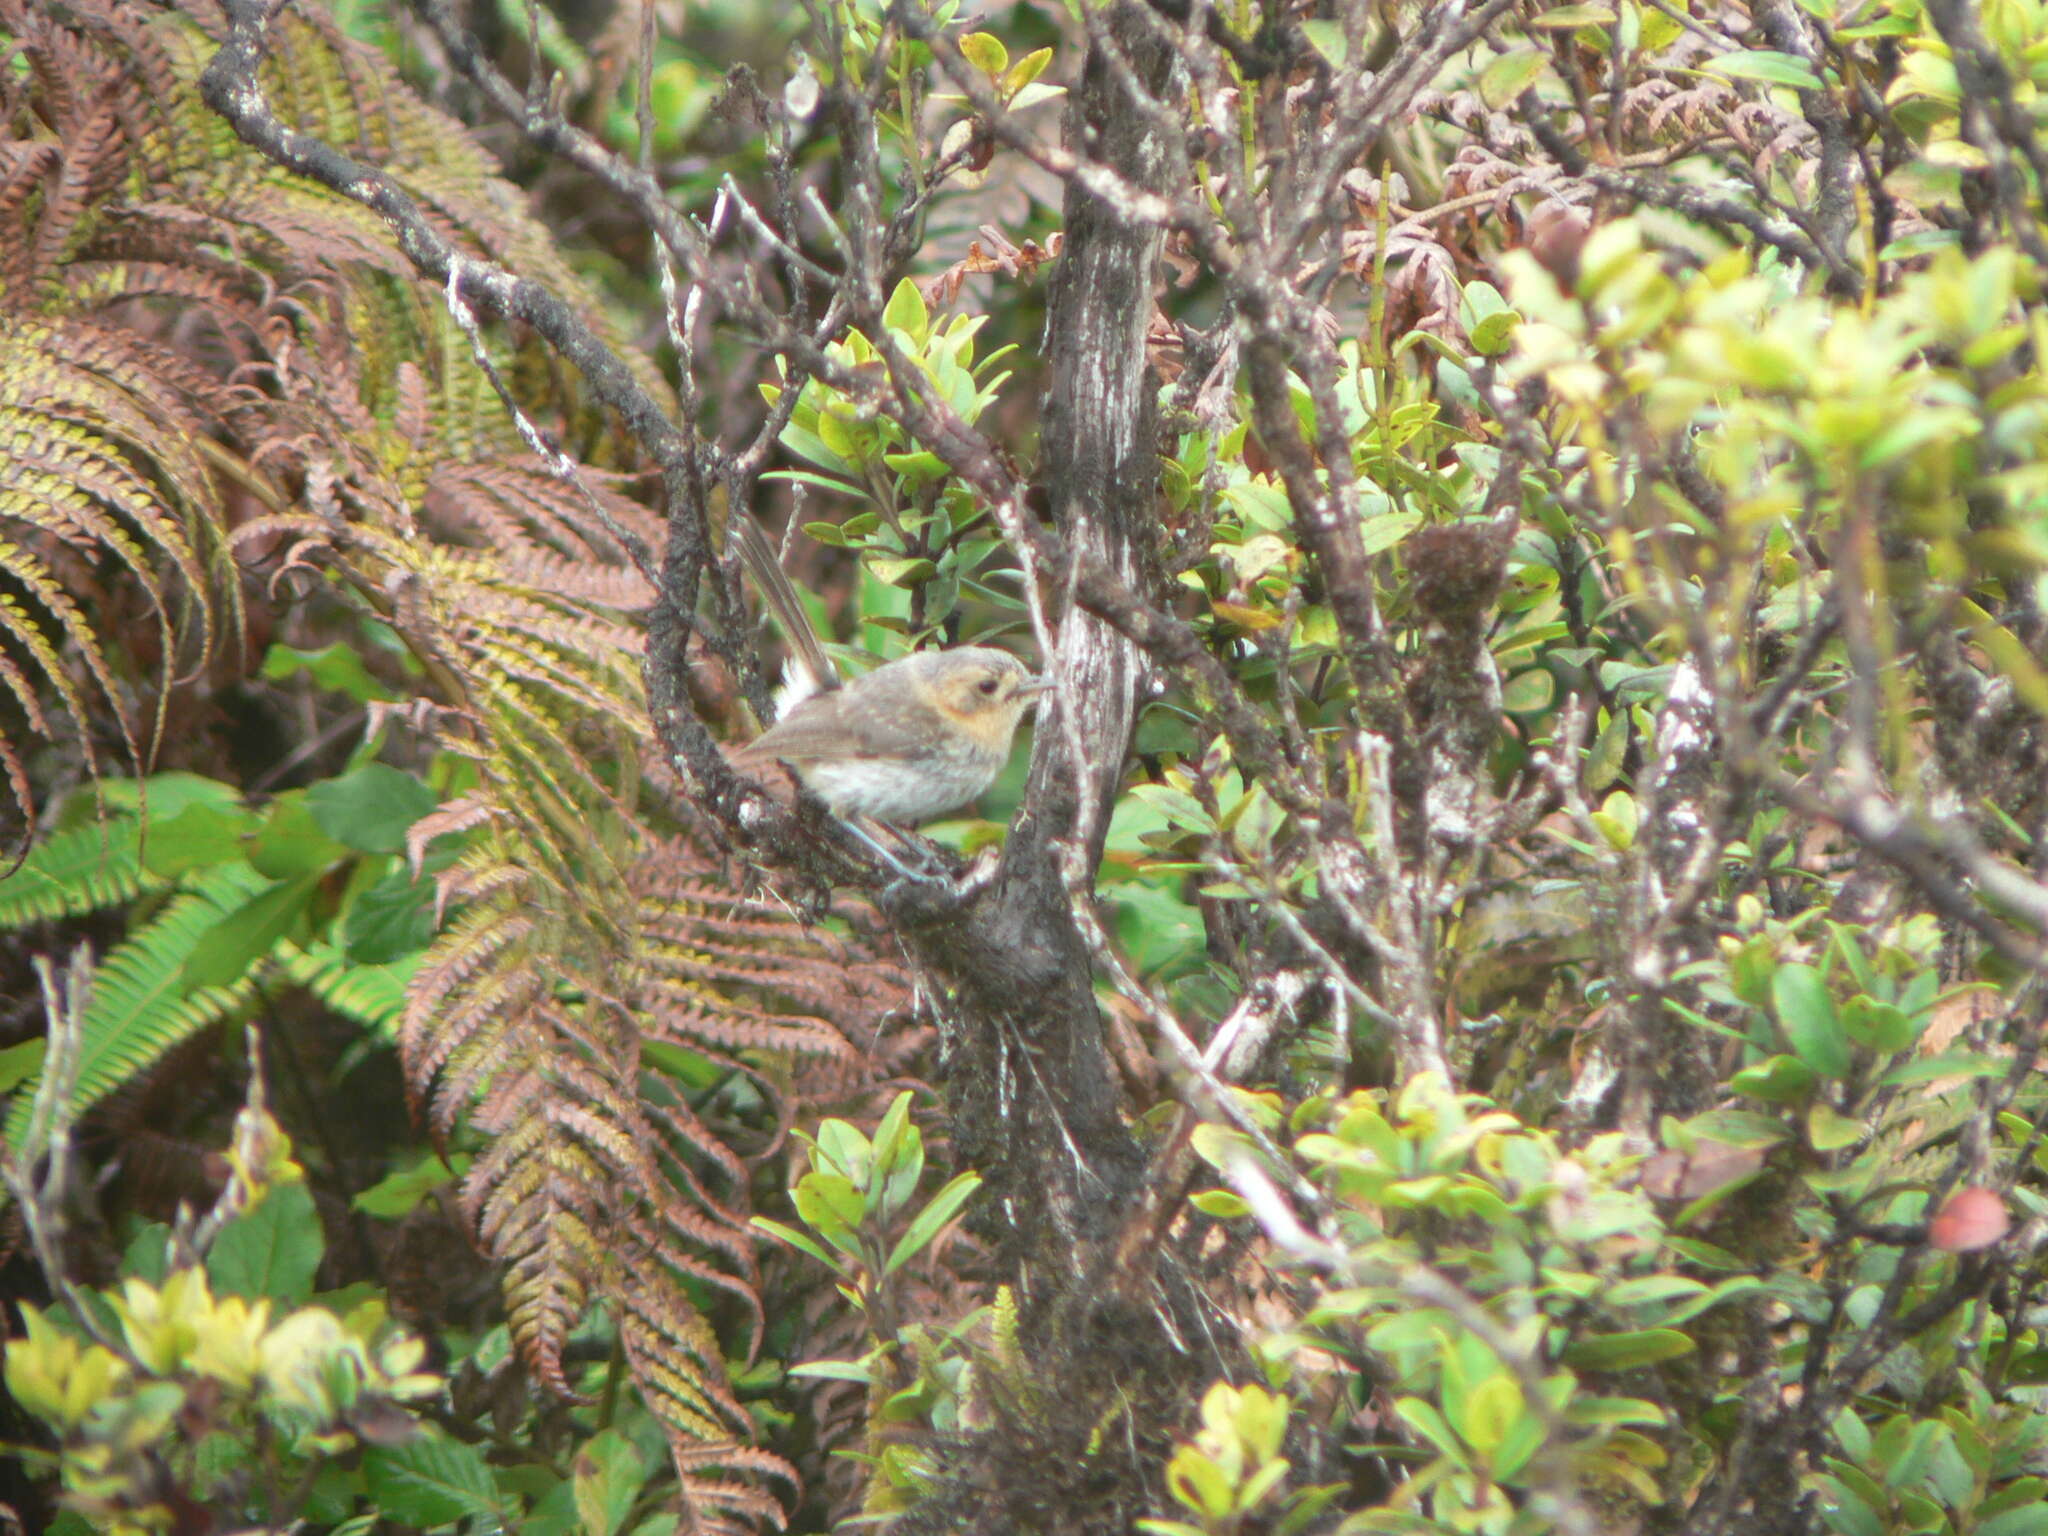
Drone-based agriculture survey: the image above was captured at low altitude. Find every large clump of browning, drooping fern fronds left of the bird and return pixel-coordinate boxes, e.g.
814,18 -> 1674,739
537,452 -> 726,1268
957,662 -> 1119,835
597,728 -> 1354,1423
0,0 -> 929,1532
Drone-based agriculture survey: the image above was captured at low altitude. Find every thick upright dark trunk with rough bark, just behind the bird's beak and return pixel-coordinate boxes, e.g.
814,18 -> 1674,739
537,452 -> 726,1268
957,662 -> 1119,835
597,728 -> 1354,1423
880,6 -> 1219,1532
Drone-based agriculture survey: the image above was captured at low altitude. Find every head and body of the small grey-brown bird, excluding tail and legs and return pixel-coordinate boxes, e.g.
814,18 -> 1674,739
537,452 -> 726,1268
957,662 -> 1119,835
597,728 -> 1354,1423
733,645 -> 1049,825
